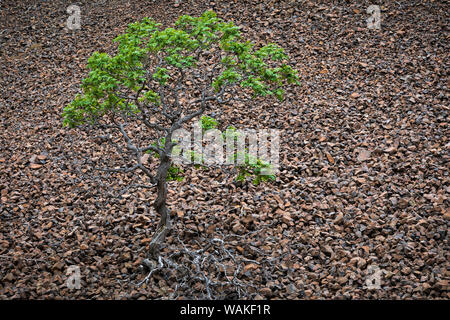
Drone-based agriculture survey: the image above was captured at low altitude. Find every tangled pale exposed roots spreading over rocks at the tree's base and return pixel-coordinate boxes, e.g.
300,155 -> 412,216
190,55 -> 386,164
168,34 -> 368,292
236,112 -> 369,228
137,225 -> 281,300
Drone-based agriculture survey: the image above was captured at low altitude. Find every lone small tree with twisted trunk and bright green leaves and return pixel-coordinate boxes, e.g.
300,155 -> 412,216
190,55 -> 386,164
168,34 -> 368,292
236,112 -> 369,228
63,11 -> 299,255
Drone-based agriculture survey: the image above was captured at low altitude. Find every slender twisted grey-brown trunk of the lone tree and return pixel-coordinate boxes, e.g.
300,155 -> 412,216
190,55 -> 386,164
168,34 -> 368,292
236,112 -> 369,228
150,154 -> 171,258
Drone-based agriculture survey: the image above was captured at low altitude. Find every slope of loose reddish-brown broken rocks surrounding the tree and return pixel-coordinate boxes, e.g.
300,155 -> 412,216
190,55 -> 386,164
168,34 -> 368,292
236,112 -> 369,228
0,0 -> 450,299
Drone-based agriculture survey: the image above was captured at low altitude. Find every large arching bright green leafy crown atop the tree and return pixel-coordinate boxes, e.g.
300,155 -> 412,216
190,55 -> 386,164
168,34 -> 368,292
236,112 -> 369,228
63,11 -> 299,127
